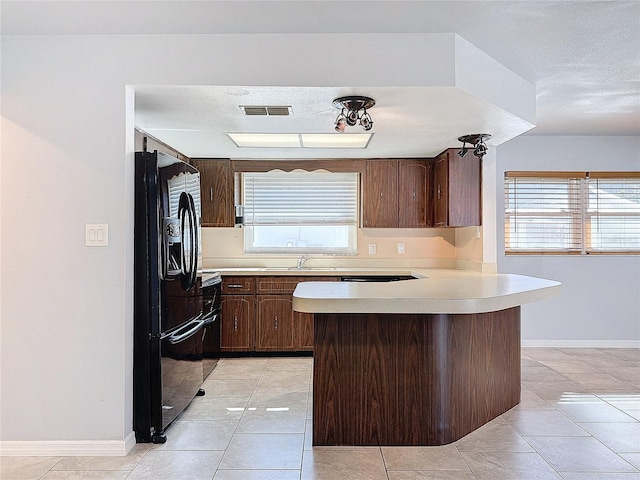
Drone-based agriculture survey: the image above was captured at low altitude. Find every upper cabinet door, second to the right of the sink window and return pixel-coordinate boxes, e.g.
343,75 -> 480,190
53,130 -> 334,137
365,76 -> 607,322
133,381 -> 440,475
398,160 -> 430,228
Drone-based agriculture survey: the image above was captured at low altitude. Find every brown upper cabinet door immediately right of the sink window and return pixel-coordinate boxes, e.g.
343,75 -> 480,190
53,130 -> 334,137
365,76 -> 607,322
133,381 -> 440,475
362,160 -> 398,228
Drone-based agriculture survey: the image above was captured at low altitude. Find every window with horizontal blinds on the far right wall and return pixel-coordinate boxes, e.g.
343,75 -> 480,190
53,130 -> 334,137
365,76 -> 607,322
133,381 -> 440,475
505,172 -> 640,254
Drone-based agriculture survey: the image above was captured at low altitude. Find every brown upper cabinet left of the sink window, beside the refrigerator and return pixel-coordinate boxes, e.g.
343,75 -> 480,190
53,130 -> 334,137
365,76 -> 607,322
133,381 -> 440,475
191,158 -> 235,227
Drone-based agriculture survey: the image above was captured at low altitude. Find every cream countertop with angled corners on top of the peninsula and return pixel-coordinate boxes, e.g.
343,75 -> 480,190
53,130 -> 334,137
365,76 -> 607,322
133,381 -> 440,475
290,269 -> 562,314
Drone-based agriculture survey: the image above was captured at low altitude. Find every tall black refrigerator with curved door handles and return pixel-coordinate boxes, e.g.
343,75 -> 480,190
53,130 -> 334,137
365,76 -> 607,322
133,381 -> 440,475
133,152 -> 219,443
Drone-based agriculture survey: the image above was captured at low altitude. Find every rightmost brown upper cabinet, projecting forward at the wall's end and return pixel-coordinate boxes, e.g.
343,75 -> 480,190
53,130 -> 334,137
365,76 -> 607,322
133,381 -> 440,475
433,148 -> 482,227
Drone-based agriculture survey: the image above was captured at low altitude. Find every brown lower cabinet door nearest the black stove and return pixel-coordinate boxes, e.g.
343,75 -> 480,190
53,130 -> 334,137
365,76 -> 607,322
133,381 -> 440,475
220,295 -> 254,352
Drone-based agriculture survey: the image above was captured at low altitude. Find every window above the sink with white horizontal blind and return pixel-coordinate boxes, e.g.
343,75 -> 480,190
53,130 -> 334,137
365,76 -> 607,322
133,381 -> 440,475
243,170 -> 358,254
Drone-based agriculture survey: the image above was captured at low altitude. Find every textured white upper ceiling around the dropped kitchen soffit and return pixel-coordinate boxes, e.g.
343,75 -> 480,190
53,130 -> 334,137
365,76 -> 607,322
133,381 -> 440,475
1,0 -> 640,158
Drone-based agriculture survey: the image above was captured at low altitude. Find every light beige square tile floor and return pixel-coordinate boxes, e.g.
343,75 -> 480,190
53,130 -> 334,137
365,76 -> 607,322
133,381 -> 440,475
0,348 -> 640,480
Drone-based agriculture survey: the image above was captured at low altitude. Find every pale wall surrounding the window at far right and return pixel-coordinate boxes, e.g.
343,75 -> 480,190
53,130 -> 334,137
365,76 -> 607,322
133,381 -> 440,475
496,136 -> 640,346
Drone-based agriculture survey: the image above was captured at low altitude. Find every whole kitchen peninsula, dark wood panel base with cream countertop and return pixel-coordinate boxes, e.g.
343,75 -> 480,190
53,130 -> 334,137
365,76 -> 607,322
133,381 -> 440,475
293,270 -> 561,445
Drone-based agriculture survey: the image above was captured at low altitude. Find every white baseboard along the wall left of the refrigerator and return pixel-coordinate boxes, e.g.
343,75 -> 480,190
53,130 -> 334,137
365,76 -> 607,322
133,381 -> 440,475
0,432 -> 136,457
